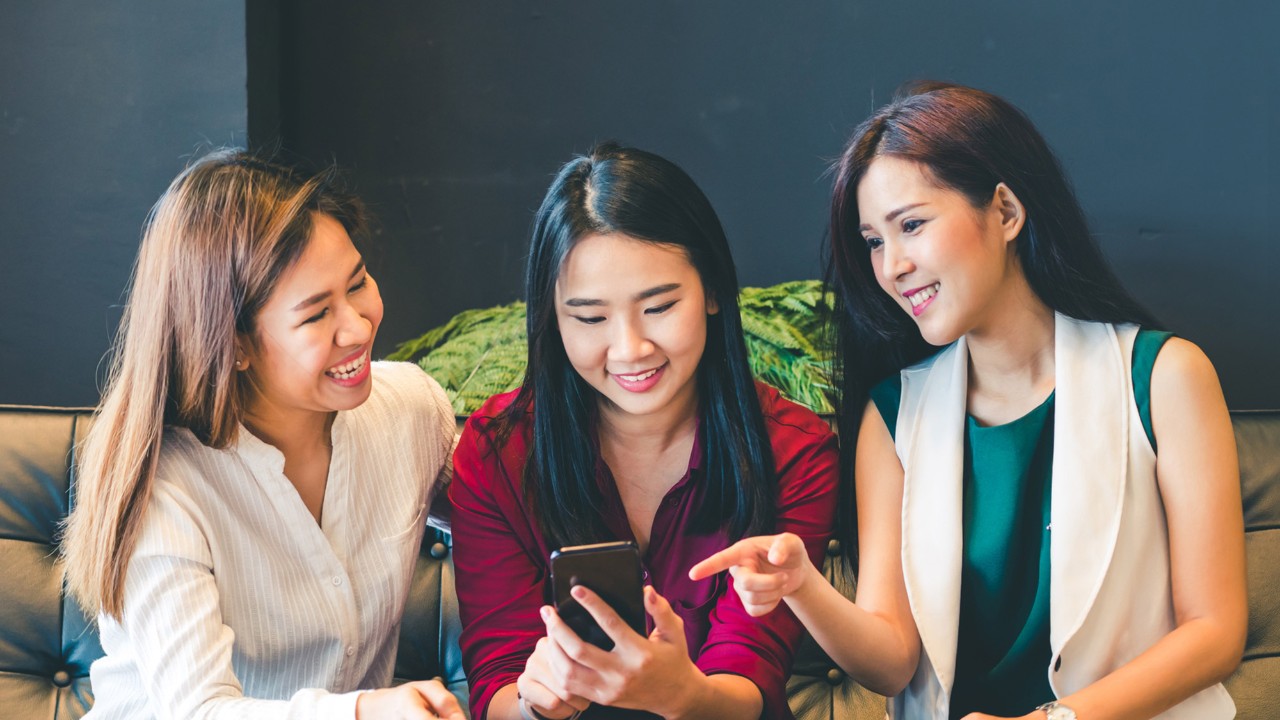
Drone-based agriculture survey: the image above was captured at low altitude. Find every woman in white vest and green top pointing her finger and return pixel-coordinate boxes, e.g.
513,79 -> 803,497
691,83 -> 1247,720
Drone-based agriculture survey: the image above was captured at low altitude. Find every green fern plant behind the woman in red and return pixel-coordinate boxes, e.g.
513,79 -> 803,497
388,281 -> 832,415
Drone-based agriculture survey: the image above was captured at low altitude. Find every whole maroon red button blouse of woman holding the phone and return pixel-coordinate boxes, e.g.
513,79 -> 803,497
449,384 -> 838,719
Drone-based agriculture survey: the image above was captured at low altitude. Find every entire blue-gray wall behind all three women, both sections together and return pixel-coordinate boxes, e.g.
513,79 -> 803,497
0,0 -> 1280,407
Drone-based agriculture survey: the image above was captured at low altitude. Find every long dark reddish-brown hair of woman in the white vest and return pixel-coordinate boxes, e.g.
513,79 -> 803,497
826,82 -> 1158,561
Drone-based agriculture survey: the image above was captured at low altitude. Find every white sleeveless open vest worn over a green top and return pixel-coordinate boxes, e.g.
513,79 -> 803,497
890,315 -> 1235,720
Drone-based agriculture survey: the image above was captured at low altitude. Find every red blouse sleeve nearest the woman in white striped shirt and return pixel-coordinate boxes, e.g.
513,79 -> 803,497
449,396 -> 547,719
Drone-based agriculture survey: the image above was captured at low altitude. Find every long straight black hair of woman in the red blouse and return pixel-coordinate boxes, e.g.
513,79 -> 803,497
494,143 -> 777,547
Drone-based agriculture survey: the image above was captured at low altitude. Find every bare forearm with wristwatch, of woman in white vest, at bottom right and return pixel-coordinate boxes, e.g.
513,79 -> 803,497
1061,618 -> 1243,720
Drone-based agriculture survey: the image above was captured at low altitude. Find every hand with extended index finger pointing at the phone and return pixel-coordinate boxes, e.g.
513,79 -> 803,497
689,533 -> 815,618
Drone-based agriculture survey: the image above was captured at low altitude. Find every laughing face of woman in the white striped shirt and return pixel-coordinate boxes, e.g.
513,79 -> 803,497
237,213 -> 383,427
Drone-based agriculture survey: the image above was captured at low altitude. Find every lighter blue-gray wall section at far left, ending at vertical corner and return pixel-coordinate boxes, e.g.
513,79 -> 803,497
0,0 -> 246,405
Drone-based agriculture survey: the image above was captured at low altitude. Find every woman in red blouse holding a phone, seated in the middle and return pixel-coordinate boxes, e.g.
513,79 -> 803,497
451,145 -> 838,720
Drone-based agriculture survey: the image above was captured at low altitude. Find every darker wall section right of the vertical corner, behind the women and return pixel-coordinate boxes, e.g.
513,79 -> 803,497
267,0 -> 1280,409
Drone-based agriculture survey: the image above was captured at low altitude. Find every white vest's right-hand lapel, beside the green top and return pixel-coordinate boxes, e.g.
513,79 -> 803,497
1050,315 -> 1133,655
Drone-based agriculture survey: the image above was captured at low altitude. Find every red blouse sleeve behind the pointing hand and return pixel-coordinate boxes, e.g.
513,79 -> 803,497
698,393 -> 840,717
